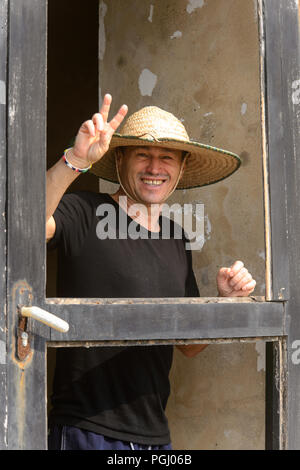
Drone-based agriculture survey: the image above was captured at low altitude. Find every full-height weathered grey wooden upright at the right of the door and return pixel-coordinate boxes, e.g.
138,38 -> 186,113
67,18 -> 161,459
264,0 -> 300,450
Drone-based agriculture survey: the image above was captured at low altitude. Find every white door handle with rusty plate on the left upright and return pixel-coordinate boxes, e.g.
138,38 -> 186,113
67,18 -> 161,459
17,305 -> 69,361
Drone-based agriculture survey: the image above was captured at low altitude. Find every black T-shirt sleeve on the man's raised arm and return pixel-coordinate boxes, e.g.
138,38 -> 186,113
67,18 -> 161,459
47,191 -> 95,256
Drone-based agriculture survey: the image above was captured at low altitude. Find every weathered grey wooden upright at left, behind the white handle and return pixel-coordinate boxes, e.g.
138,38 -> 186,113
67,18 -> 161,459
7,0 -> 48,449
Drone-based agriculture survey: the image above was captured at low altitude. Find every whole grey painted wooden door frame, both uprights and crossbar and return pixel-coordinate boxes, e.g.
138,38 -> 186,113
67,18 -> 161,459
0,0 -> 300,449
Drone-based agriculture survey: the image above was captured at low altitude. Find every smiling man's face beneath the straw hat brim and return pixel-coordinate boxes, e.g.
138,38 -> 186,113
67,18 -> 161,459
118,146 -> 182,205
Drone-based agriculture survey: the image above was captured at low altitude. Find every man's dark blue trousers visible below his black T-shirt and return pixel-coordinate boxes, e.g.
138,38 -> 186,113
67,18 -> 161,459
48,425 -> 172,450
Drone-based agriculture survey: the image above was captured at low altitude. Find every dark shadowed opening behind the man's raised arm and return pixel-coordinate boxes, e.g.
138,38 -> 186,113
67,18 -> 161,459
47,0 -> 99,297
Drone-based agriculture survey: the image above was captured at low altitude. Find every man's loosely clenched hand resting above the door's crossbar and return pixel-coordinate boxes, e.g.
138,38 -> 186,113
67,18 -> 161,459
217,261 -> 256,297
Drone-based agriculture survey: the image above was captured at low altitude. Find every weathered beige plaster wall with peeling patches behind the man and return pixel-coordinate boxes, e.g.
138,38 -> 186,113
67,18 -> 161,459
99,0 -> 265,449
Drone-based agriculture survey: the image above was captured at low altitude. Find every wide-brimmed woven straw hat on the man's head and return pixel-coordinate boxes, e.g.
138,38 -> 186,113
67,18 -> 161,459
90,106 -> 241,189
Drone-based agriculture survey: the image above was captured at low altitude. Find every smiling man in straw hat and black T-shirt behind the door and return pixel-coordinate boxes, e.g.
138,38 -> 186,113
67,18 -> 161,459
46,95 -> 255,450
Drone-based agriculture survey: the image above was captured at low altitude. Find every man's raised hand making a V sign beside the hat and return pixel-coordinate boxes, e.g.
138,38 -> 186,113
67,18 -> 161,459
68,94 -> 128,168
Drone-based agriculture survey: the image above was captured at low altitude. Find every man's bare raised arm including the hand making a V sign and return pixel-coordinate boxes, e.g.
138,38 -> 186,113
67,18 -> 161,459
46,95 -> 128,241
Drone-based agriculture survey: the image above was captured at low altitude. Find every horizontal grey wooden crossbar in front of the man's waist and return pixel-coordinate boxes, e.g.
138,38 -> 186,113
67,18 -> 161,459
42,298 -> 285,341
